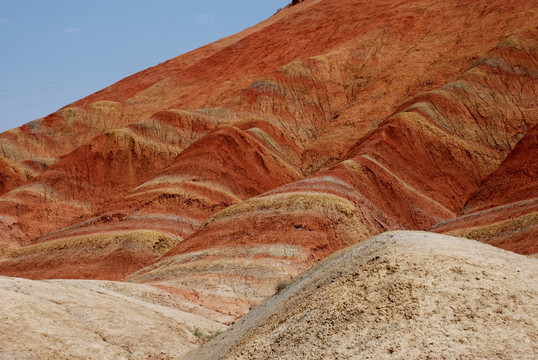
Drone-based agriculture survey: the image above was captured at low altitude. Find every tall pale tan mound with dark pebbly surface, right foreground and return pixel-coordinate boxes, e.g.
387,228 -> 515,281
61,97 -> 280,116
184,231 -> 538,359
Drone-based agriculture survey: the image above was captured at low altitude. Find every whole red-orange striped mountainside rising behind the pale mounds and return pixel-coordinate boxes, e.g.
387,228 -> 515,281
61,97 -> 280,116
0,0 -> 538,358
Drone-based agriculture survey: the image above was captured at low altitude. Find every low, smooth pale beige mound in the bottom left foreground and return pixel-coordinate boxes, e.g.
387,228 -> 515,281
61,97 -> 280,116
0,277 -> 224,360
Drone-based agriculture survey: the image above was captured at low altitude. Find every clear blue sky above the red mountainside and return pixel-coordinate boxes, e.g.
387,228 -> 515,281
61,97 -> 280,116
0,0 -> 290,133
